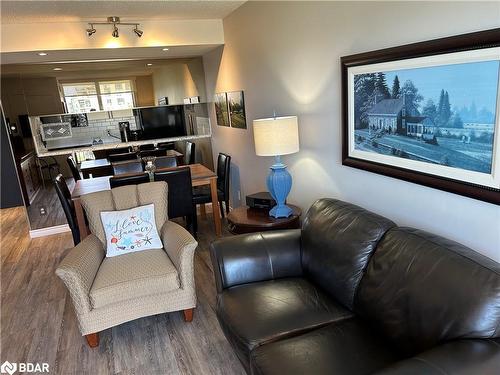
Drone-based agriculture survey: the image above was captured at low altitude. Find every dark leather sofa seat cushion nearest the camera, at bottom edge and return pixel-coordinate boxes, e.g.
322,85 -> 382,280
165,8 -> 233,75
250,318 -> 399,375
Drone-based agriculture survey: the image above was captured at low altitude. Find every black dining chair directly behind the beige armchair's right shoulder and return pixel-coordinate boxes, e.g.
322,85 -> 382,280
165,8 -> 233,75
154,167 -> 198,235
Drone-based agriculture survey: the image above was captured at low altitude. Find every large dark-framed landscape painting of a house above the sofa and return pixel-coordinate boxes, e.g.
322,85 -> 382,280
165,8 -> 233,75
341,29 -> 500,204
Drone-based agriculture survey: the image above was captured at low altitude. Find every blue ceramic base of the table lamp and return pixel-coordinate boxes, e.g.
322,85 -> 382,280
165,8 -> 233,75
267,156 -> 292,218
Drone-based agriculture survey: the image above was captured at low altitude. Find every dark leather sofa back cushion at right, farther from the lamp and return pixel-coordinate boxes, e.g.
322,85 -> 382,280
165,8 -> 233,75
355,228 -> 500,355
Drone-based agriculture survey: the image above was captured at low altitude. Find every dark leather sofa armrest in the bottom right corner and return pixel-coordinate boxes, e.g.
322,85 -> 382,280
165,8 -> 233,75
376,339 -> 500,375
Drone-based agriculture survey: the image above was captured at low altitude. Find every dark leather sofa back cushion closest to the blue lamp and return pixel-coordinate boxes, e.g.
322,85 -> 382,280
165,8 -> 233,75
302,199 -> 395,309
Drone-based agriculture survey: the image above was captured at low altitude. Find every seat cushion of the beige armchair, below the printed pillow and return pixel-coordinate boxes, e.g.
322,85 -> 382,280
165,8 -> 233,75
90,249 -> 180,308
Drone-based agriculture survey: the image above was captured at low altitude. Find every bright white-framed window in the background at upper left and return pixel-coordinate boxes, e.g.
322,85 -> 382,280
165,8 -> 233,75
62,80 -> 135,113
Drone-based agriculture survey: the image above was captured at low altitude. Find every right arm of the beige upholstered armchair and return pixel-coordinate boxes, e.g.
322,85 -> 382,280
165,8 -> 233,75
160,220 -> 198,289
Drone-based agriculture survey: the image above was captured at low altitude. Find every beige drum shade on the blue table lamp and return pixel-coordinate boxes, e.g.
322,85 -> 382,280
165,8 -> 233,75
253,116 -> 299,156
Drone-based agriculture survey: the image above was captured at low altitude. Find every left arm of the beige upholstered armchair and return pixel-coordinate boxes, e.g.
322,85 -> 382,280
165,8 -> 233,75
56,234 -> 105,315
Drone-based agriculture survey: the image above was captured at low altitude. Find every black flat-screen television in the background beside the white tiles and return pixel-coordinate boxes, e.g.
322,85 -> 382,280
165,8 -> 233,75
134,105 -> 187,139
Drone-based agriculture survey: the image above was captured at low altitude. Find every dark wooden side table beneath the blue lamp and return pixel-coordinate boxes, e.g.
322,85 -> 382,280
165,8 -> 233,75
227,204 -> 302,234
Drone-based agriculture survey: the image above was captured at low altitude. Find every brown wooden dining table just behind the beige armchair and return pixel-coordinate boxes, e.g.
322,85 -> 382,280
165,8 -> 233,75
71,164 -> 222,240
